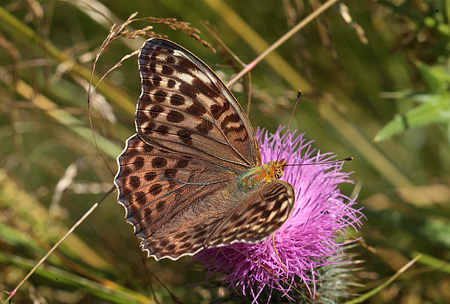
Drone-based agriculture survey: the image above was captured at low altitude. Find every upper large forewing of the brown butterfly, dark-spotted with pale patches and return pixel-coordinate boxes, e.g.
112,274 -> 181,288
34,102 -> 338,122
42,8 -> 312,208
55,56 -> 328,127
136,39 -> 261,169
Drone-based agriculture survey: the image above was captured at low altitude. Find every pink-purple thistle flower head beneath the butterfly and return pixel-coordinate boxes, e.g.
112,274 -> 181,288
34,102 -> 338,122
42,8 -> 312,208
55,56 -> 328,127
195,127 -> 363,303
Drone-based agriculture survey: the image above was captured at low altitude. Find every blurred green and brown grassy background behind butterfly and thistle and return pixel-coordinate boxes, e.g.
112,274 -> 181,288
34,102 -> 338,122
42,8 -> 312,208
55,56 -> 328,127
0,0 -> 450,303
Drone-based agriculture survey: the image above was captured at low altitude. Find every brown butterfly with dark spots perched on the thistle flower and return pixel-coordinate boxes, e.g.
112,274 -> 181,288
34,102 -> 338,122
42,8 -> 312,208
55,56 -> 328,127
115,38 -> 295,260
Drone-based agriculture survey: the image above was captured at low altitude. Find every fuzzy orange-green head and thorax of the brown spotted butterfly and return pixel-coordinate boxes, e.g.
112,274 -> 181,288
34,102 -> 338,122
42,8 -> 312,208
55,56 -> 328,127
241,159 -> 286,188
